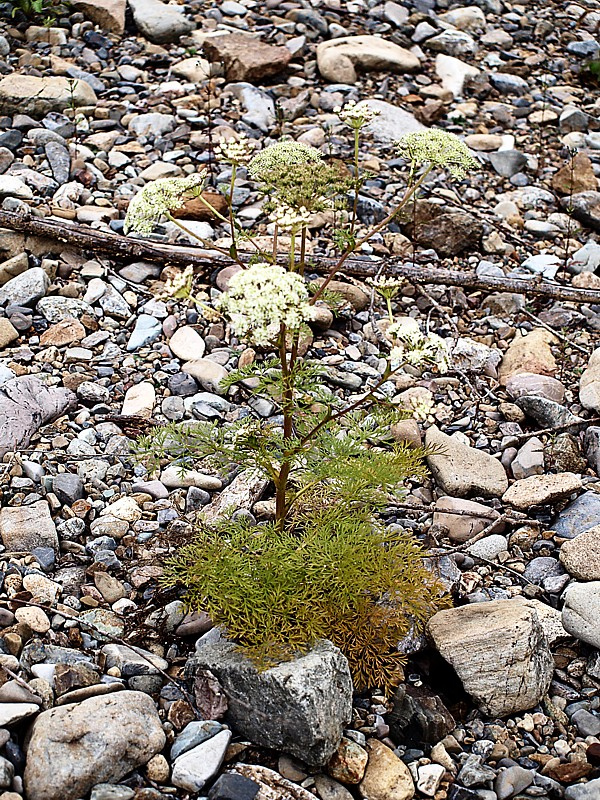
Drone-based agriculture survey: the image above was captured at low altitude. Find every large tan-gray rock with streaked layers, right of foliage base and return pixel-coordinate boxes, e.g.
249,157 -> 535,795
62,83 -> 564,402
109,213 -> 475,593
428,600 -> 554,717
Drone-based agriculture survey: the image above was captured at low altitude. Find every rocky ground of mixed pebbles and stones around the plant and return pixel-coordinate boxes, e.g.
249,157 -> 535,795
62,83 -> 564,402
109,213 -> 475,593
0,0 -> 600,800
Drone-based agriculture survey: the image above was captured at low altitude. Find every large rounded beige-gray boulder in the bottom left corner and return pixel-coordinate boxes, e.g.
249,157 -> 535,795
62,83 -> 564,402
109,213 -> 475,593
25,691 -> 166,800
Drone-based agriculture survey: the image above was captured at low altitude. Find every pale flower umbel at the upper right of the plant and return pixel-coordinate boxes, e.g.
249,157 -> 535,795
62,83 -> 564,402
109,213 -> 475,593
396,128 -> 478,179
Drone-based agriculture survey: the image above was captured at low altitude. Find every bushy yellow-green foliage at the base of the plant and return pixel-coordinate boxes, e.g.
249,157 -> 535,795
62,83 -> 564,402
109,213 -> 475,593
166,506 -> 441,690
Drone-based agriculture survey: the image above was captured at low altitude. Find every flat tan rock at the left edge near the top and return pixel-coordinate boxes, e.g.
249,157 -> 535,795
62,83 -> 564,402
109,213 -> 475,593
0,74 -> 98,119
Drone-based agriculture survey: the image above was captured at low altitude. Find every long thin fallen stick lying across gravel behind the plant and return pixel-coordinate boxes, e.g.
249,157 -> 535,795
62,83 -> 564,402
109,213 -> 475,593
0,211 -> 600,304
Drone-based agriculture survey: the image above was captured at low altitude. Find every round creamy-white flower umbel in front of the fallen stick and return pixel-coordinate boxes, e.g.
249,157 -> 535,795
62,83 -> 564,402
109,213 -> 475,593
216,264 -> 314,346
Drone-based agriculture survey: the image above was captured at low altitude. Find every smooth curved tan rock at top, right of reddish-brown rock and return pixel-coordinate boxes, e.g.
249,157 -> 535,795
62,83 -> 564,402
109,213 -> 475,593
317,36 -> 420,83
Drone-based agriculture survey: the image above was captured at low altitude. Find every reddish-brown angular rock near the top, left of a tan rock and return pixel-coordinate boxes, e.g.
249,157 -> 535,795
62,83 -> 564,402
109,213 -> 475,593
203,33 -> 292,83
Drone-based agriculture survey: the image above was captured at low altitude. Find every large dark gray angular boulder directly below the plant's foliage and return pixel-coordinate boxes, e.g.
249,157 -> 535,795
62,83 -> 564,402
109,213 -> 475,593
185,640 -> 352,766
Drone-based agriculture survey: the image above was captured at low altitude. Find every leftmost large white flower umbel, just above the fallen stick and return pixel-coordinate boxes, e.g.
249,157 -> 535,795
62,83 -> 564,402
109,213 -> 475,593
124,170 -> 206,233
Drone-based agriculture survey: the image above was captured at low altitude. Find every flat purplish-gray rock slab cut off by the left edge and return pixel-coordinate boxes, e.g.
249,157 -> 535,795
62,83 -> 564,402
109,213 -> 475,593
0,375 -> 77,458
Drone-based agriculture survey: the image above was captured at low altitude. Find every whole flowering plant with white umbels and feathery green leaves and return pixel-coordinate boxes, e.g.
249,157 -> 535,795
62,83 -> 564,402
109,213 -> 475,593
127,114 -> 472,688
